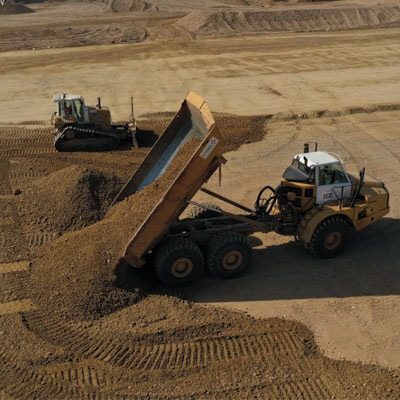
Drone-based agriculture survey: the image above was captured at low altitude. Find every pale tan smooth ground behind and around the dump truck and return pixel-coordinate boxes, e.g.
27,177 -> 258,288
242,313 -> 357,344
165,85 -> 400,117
0,2 -> 400,398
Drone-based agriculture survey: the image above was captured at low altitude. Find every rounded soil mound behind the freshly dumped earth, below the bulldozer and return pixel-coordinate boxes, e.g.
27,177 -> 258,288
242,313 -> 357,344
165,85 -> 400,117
18,166 -> 122,234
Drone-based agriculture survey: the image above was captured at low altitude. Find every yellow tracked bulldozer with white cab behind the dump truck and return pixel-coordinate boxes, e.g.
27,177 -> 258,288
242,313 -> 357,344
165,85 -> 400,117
51,93 -> 138,151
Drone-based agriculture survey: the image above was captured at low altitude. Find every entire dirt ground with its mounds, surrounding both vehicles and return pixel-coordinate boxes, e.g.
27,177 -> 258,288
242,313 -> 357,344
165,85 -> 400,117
0,0 -> 400,400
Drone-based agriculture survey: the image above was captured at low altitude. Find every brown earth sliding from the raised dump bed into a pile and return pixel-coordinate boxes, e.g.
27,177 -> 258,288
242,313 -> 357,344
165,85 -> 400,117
30,140 -> 198,319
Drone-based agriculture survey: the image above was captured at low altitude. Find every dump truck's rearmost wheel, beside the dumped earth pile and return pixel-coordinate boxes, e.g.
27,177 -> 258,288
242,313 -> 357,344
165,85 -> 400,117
153,238 -> 204,286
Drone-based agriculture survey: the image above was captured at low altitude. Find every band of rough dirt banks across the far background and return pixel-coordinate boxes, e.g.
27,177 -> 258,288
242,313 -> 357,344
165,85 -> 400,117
0,0 -> 400,51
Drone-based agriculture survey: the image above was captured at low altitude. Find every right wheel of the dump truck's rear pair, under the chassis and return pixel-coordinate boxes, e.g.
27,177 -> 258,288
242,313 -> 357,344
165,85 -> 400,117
207,232 -> 253,279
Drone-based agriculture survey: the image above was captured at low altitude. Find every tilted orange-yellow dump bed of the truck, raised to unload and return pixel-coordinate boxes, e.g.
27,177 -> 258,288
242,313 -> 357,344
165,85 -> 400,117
115,92 -> 225,268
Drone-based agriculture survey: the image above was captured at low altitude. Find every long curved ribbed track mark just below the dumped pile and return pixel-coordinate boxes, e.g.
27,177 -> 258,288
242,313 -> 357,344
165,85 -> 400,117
24,311 -> 305,370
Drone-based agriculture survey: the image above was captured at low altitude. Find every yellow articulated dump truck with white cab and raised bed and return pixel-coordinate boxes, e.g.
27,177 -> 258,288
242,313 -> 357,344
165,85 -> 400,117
114,92 -> 389,285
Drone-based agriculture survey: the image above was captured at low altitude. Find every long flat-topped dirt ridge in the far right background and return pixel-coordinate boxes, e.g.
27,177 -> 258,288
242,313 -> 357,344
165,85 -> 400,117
176,6 -> 400,36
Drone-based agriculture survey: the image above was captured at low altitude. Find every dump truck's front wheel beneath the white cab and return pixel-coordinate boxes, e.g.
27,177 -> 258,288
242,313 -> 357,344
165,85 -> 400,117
309,216 -> 353,258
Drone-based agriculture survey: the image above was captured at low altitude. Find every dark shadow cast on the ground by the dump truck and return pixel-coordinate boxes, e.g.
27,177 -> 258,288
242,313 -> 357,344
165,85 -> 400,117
192,218 -> 400,302
